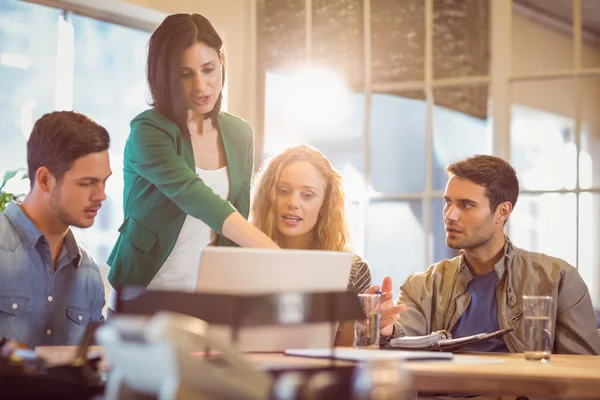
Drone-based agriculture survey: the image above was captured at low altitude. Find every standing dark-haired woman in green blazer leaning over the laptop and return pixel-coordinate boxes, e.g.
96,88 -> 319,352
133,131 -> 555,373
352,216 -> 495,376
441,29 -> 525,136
108,14 -> 277,310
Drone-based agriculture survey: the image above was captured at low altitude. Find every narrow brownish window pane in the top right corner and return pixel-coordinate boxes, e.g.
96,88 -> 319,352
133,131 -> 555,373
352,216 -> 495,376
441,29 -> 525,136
581,0 -> 600,68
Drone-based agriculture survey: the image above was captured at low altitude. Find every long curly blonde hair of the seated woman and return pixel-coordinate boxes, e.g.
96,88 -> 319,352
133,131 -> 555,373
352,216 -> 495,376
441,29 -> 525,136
250,146 -> 350,251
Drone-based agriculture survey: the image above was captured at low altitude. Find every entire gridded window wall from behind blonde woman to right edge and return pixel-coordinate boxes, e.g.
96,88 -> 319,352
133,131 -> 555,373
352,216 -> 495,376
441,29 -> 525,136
259,0 -> 600,304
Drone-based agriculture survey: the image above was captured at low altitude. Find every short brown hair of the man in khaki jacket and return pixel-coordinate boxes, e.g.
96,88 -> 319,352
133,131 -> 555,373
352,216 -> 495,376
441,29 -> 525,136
446,154 -> 519,212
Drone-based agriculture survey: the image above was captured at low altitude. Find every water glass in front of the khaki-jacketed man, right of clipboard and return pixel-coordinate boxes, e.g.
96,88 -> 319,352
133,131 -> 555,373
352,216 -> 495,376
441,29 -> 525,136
523,296 -> 552,361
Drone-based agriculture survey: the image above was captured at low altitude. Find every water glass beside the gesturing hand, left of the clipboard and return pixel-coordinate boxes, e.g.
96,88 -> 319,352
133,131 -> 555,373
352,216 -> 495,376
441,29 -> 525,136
354,293 -> 381,349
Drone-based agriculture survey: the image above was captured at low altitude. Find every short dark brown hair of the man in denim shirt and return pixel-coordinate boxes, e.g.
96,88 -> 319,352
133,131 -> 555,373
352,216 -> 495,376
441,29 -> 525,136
27,111 -> 110,187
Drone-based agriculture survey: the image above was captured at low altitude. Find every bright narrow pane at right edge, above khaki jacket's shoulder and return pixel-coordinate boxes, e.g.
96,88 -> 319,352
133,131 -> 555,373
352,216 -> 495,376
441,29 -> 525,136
578,193 -> 600,306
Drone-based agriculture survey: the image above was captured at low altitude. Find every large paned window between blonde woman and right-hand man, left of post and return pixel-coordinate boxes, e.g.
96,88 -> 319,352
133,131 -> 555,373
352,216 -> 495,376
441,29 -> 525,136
263,0 -> 492,293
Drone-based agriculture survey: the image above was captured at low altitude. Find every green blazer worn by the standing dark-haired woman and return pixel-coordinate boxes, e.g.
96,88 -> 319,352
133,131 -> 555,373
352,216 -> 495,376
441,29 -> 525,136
107,109 -> 254,288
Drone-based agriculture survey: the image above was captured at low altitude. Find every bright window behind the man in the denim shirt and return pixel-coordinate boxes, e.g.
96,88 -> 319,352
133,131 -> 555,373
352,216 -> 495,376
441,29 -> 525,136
0,0 -> 150,265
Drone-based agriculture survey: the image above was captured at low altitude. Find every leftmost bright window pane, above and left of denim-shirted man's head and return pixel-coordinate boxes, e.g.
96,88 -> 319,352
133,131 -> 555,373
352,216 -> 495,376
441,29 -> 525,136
0,1 -> 60,176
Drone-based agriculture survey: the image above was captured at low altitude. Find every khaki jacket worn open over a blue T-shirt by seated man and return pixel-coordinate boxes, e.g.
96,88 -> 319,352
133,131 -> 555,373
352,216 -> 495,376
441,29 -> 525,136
394,238 -> 600,355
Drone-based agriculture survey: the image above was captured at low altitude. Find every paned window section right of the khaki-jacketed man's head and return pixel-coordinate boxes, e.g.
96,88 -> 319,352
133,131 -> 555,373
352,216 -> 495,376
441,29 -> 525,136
508,0 -> 600,305
